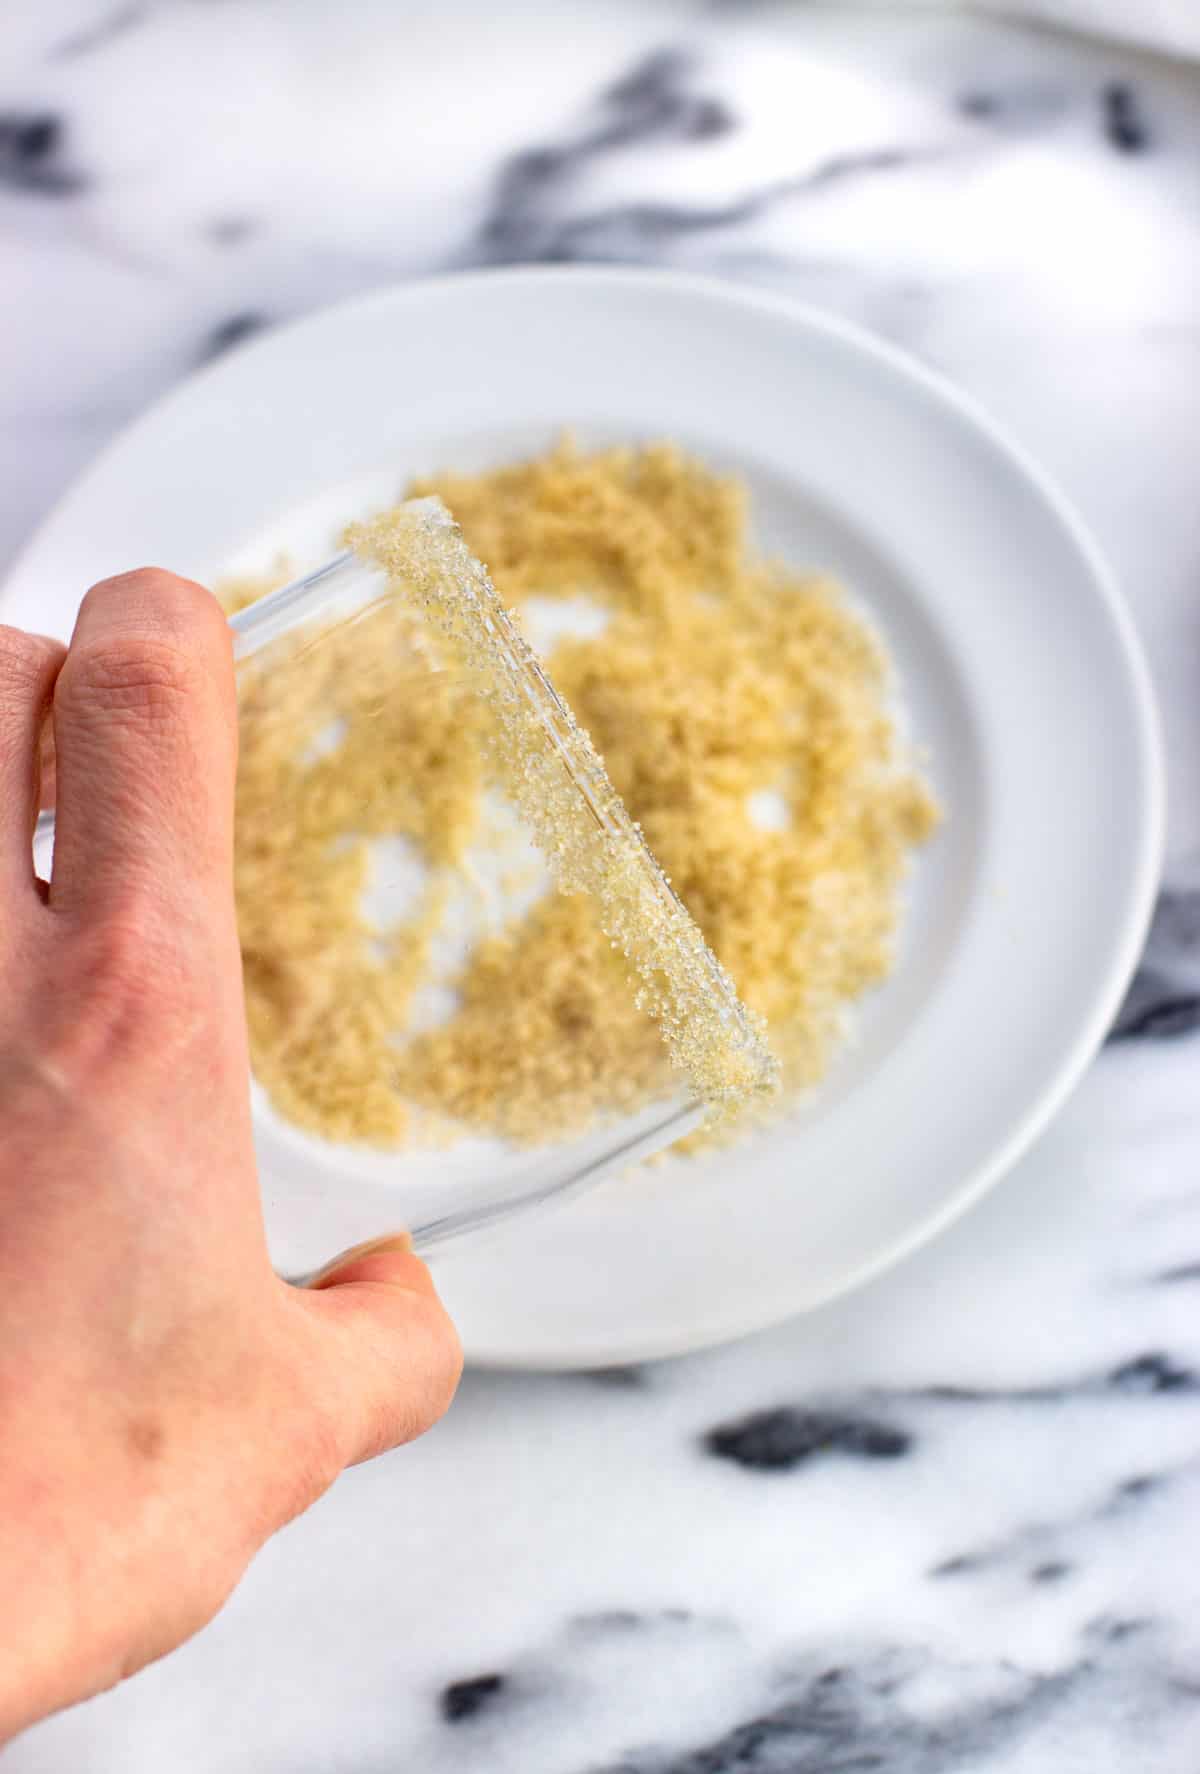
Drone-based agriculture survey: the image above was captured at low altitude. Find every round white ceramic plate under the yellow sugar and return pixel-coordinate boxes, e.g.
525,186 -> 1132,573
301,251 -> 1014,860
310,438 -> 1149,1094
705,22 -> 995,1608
0,270 -> 1163,1366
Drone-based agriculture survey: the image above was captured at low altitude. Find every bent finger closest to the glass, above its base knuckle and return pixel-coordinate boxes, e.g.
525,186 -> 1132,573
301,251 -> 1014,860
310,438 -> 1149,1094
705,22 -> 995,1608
50,568 -> 236,912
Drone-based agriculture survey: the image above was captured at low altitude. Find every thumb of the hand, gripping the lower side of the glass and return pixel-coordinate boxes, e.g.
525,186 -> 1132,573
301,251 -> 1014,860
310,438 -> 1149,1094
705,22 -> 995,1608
296,1235 -> 463,1465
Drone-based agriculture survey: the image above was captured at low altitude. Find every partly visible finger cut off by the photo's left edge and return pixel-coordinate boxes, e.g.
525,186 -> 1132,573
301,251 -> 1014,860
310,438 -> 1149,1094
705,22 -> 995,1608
0,626 -> 66,903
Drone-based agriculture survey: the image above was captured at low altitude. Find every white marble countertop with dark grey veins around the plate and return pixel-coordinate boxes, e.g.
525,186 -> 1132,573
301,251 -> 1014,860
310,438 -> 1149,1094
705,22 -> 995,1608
0,0 -> 1200,1774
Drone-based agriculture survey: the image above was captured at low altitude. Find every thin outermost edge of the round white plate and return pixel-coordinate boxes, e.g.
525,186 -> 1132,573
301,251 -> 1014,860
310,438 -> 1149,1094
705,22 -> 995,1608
0,264 -> 1166,1371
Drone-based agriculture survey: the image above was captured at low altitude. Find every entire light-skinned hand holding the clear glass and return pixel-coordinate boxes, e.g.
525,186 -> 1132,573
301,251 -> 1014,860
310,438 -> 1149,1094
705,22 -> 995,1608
0,569 -> 460,1742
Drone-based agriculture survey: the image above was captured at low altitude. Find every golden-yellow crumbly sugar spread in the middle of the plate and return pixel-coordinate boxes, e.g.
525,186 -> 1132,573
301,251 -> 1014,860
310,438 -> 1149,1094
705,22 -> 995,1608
227,444 -> 937,1146
